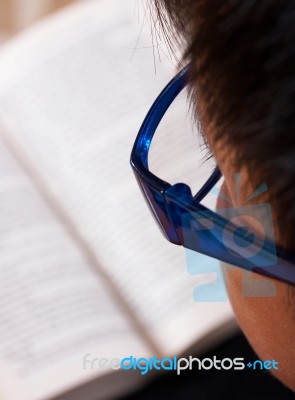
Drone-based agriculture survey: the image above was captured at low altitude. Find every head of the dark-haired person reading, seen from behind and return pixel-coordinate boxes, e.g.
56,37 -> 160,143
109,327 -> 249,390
154,0 -> 295,390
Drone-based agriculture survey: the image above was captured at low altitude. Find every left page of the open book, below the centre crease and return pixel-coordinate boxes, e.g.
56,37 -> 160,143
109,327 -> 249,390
0,126 -> 151,400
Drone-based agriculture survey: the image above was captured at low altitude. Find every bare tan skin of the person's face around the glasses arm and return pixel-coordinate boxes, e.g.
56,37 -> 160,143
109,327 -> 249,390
215,149 -> 295,391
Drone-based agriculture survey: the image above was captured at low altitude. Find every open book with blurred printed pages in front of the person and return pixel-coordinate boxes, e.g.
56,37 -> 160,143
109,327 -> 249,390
0,0 -> 238,400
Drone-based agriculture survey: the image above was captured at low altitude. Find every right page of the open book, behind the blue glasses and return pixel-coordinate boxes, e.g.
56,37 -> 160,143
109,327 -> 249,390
0,0 -> 237,360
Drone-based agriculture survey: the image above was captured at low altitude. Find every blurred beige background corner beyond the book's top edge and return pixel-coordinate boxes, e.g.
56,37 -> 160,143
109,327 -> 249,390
0,0 -> 76,43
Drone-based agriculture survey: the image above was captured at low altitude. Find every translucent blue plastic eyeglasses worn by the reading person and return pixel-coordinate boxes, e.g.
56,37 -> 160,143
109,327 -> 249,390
130,66 -> 295,285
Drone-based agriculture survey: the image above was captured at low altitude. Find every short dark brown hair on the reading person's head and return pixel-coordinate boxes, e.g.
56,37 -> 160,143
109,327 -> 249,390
154,0 -> 295,251
